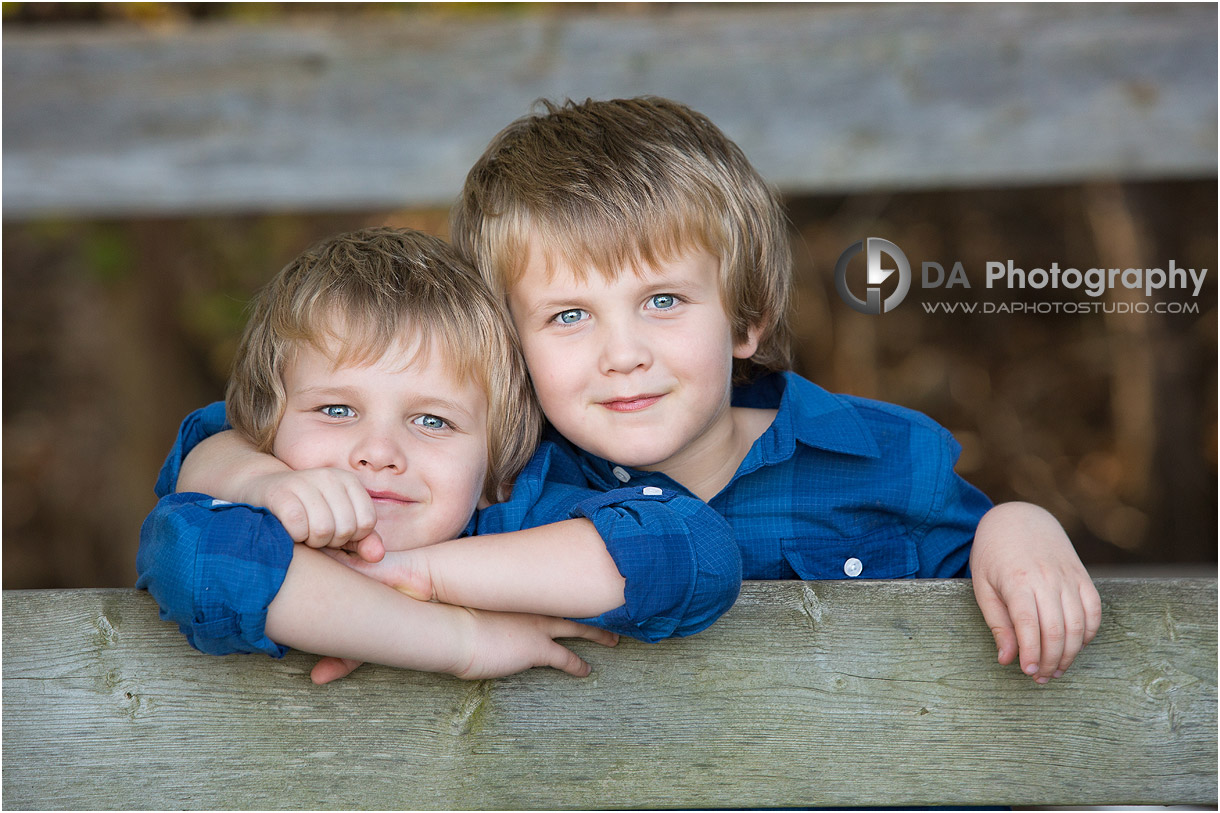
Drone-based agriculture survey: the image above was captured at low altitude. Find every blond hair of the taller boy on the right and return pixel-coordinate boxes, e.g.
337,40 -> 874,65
450,96 -> 792,382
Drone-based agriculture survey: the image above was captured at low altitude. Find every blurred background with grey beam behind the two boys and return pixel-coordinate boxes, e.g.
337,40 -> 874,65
2,2 -> 1218,588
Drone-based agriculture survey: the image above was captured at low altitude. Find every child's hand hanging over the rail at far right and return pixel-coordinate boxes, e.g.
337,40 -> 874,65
970,503 -> 1102,684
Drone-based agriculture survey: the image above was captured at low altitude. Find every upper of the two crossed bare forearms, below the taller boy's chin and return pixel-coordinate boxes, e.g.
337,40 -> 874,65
412,519 -> 626,618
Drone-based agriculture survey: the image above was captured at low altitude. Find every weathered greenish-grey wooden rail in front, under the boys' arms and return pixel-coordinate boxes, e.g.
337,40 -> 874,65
4,579 -> 1216,809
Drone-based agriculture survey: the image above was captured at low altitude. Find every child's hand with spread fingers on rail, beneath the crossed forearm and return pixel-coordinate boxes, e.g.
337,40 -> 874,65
454,609 -> 619,680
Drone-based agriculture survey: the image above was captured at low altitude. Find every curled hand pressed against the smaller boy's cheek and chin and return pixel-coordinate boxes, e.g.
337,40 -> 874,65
242,469 -> 386,562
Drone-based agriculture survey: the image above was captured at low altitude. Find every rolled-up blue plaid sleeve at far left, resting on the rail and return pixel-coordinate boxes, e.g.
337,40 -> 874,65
135,493 -> 293,658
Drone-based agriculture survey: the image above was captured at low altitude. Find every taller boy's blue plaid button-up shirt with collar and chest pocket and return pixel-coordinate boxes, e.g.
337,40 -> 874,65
490,372 -> 991,579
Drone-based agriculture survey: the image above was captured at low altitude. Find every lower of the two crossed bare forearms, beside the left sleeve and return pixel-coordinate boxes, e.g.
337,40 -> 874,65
266,546 -> 472,674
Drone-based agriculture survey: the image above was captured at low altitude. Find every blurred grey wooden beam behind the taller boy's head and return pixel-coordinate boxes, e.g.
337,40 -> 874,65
4,4 -> 1216,220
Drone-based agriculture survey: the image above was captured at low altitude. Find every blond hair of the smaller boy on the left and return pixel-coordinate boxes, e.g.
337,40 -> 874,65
224,228 -> 542,502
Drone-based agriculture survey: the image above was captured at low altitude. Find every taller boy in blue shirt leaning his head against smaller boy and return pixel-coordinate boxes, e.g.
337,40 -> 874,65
159,99 -> 1100,682
